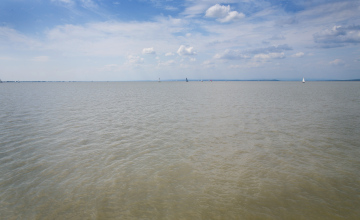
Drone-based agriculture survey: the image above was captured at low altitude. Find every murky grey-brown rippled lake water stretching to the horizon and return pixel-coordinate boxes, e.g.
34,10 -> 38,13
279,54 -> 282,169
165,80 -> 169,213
0,82 -> 360,219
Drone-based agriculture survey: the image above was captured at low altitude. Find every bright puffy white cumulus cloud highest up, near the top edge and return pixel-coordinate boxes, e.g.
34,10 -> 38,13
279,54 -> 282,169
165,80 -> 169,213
205,4 -> 245,23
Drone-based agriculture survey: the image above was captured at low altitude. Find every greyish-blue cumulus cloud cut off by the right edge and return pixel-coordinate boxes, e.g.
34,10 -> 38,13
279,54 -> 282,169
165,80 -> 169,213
313,25 -> 360,48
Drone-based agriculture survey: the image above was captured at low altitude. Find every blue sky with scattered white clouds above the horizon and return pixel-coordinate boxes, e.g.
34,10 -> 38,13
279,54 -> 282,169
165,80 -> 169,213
0,0 -> 360,81
